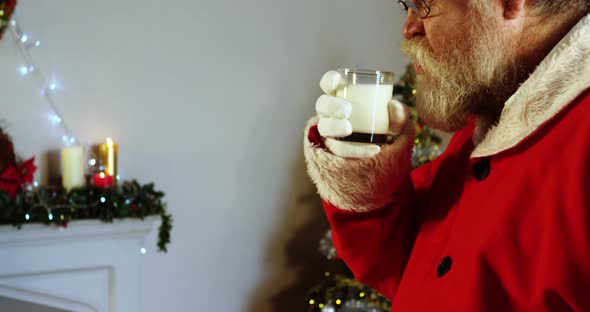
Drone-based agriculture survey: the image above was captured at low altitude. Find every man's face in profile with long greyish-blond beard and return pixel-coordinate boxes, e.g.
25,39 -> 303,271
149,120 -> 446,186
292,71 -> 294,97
402,0 -> 518,131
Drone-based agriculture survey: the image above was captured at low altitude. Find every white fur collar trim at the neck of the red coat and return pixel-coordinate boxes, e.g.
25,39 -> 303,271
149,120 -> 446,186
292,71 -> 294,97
471,15 -> 590,158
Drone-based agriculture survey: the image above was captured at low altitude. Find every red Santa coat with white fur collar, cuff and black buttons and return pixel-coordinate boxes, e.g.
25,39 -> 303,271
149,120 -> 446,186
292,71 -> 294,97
305,13 -> 590,312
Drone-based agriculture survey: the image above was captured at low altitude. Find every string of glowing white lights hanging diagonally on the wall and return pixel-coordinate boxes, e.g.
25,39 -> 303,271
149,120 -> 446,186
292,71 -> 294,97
10,18 -> 79,145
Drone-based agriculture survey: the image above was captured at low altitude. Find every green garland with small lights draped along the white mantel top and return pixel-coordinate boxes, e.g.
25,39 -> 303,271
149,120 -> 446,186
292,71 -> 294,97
0,180 -> 172,252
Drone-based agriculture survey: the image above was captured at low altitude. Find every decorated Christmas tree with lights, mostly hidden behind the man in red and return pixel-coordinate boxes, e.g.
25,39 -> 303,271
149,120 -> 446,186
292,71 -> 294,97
307,64 -> 442,312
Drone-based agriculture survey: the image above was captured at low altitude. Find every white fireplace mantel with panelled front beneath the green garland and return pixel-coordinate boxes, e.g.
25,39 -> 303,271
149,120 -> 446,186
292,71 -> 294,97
0,217 -> 159,312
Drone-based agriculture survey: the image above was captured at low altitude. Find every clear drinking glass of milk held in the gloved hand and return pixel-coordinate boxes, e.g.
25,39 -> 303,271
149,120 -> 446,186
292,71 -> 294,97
336,69 -> 394,144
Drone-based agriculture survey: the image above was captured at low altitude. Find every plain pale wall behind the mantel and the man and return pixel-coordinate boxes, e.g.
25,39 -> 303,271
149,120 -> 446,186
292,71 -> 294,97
0,0 -> 405,311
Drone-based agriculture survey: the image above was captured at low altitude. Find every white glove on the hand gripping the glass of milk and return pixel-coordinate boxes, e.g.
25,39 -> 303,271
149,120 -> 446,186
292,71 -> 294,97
315,71 -> 409,158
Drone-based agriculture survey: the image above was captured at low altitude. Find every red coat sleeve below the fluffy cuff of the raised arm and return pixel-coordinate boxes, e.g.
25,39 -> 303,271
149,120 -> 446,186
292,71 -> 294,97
323,177 -> 418,300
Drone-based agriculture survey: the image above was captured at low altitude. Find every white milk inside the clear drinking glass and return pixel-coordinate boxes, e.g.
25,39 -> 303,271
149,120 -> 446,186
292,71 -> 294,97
336,84 -> 393,134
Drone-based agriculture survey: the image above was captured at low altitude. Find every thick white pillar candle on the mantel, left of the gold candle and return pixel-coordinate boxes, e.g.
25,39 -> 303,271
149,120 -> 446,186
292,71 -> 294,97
61,145 -> 86,190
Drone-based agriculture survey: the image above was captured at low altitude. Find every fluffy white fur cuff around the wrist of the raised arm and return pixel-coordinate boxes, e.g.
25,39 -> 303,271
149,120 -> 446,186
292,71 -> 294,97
303,117 -> 414,212
